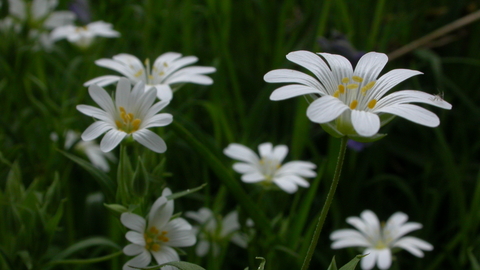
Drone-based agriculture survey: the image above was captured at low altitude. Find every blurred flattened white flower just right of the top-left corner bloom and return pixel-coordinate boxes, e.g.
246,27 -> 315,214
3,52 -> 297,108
50,21 -> 120,48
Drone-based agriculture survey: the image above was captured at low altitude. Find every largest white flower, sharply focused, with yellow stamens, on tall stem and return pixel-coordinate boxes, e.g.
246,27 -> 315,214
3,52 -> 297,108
264,51 -> 452,138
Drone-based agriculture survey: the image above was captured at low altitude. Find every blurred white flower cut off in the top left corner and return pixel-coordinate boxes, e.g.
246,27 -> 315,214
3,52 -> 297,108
0,0 -> 76,49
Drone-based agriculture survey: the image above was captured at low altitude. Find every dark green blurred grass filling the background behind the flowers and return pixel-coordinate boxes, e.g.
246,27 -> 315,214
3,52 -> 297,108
0,0 -> 480,270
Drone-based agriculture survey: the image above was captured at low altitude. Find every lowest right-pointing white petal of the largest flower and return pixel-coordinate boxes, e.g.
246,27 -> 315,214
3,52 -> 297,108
376,104 -> 440,127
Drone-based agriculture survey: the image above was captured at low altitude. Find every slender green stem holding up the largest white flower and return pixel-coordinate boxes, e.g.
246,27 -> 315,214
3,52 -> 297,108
302,137 -> 348,270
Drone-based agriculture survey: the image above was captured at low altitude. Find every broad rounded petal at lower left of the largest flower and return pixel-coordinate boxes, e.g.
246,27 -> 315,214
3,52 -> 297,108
307,96 -> 349,124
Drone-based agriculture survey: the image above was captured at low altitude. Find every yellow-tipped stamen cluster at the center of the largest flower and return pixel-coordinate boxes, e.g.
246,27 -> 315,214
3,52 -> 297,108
333,76 -> 377,110
